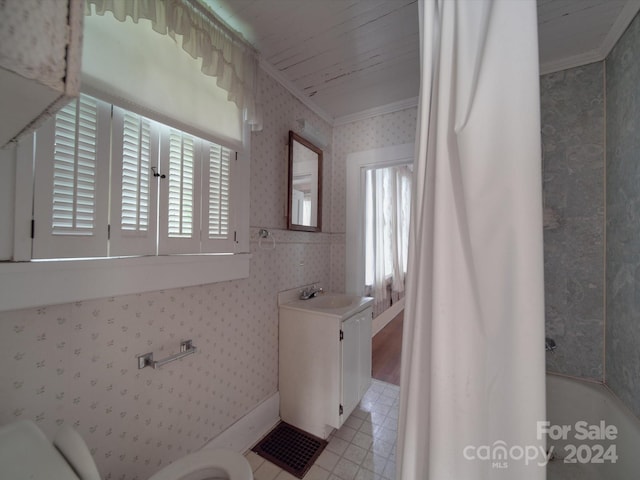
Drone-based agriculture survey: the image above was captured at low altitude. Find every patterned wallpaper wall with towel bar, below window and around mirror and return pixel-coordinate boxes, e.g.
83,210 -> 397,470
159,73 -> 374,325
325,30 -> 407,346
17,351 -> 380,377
0,69 -> 332,480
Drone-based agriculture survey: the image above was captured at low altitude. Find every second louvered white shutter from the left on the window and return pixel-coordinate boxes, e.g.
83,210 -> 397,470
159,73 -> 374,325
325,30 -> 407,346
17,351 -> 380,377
109,107 -> 162,256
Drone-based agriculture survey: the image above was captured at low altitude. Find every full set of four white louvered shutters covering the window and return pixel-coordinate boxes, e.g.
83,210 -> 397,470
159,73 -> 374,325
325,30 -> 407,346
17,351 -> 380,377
32,95 -> 238,259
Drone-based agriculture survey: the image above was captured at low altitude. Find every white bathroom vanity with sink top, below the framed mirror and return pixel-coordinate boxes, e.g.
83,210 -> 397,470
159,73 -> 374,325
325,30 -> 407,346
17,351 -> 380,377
279,293 -> 373,438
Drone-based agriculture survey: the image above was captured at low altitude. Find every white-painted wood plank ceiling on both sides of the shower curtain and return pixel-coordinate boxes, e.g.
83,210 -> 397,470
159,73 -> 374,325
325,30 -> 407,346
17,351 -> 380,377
203,0 -> 640,119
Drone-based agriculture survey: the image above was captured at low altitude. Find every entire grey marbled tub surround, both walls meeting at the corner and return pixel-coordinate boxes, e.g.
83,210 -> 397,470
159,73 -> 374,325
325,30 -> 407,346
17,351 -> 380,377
541,9 -> 640,417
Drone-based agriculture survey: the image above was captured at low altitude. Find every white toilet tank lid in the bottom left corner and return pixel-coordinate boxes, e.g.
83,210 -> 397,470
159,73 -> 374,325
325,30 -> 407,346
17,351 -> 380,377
0,420 -> 78,480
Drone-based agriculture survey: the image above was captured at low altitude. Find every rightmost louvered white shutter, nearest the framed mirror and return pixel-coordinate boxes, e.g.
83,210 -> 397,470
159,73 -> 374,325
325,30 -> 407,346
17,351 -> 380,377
202,142 -> 236,253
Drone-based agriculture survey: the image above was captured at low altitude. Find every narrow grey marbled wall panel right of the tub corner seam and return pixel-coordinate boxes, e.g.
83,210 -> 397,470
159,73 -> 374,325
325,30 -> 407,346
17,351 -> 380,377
606,11 -> 640,417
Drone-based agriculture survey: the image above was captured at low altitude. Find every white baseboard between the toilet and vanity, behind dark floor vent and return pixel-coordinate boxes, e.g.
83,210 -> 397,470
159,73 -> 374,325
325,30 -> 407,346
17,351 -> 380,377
202,392 -> 280,453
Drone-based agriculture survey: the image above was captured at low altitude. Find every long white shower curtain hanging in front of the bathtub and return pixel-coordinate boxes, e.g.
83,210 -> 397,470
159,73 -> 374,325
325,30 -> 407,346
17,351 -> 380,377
397,0 -> 545,480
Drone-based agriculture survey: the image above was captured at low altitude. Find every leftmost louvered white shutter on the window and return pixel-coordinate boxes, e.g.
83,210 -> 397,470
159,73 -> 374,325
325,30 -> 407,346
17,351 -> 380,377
33,95 -> 111,258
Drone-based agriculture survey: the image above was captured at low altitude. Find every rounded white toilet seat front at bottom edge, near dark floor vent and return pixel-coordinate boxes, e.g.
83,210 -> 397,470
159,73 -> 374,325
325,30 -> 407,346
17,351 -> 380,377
149,450 -> 253,480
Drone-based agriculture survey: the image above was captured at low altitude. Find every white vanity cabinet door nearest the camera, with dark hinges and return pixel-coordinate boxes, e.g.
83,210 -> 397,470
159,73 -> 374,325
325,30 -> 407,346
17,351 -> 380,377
340,315 -> 361,425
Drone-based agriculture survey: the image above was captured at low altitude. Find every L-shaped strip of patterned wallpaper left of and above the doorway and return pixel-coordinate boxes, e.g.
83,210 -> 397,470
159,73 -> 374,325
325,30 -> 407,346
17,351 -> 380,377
331,107 -> 418,291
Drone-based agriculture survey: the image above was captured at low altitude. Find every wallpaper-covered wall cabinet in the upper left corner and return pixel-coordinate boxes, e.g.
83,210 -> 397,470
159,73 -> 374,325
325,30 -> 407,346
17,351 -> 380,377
0,0 -> 84,147
